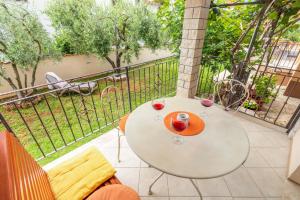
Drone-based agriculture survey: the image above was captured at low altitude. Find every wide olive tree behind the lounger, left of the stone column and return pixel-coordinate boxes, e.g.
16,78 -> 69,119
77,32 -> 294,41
47,0 -> 161,69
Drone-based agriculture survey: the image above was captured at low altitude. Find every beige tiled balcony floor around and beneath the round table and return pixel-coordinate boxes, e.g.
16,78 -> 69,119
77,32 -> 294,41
44,114 -> 300,200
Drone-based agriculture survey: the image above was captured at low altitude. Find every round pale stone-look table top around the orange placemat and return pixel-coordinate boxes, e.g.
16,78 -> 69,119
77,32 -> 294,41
125,97 -> 249,179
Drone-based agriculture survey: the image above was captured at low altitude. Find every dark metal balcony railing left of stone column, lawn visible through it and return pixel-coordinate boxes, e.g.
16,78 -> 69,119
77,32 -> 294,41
0,57 -> 178,160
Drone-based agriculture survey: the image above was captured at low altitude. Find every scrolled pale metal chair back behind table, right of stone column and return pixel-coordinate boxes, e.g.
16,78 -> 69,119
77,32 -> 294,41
214,79 -> 249,111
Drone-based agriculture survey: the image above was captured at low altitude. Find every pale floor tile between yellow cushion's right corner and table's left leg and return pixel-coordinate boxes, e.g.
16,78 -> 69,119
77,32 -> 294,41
116,168 -> 140,191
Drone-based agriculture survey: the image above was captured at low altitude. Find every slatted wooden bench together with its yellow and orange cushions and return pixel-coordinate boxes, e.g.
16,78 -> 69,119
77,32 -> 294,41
0,132 -> 140,200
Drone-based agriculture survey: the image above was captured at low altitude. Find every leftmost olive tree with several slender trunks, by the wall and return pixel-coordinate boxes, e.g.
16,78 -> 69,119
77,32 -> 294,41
0,1 -> 58,97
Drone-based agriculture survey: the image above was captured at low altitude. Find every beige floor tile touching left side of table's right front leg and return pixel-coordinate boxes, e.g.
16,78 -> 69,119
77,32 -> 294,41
168,175 -> 198,197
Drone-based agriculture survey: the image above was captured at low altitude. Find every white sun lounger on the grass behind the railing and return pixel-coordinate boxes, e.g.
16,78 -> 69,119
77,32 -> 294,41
45,72 -> 97,96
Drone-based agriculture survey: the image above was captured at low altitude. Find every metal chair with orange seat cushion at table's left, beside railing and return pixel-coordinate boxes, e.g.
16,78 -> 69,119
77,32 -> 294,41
101,86 -> 129,162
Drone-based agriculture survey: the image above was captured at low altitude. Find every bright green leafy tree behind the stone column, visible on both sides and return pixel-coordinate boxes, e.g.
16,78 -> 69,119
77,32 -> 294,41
158,0 -> 258,68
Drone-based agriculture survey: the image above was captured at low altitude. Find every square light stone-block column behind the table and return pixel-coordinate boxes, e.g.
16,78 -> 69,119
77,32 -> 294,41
176,0 -> 210,98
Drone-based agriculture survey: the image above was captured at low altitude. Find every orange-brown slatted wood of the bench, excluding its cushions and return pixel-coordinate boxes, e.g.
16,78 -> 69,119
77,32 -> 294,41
0,132 -> 121,200
